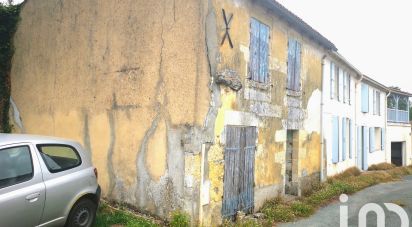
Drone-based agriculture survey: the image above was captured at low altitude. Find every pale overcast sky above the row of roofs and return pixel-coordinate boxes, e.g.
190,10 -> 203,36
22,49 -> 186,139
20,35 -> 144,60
278,0 -> 412,93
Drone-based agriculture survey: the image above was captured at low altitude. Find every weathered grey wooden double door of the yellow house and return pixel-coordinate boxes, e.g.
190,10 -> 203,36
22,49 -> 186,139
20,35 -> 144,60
222,126 -> 256,218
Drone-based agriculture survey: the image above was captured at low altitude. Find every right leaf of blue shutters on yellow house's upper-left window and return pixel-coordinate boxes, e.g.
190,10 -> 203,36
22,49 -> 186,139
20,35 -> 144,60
259,23 -> 269,83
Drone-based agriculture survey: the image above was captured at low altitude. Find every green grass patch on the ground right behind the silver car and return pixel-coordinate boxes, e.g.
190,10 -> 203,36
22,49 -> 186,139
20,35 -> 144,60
94,202 -> 159,227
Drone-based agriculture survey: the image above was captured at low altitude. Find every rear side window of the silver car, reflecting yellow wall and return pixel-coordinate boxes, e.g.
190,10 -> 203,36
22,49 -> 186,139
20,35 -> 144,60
37,144 -> 81,173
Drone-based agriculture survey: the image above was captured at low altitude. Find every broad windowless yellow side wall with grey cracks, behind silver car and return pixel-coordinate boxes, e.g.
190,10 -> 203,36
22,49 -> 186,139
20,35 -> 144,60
11,0 -> 210,221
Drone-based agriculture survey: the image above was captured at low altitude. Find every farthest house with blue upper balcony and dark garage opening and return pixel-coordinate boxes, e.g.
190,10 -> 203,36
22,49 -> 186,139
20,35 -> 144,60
386,87 -> 412,166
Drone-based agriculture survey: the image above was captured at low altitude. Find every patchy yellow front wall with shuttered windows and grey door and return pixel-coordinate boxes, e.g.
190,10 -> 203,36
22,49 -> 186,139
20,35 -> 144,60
201,0 -> 323,223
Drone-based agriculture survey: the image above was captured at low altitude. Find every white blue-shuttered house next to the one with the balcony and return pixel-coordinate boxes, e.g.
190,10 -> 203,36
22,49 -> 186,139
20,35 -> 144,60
355,75 -> 389,170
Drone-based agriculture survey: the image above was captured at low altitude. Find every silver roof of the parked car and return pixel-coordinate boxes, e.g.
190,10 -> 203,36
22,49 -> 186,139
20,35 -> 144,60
0,133 -> 78,146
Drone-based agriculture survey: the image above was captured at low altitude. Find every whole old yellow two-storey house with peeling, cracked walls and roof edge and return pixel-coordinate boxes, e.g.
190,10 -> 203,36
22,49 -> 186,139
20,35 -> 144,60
11,0 -> 337,226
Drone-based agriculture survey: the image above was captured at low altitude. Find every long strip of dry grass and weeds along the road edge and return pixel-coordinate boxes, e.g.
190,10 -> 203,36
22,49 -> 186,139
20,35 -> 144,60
261,163 -> 412,223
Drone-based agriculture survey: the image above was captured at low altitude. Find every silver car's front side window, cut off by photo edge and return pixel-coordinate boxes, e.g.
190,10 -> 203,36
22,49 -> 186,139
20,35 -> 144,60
0,146 -> 33,188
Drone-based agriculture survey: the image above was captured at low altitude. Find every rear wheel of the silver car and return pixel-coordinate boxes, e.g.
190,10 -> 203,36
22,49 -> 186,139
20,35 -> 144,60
66,199 -> 97,227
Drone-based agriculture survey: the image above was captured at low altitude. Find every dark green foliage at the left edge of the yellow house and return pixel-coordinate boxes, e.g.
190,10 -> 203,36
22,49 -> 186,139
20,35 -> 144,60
0,3 -> 21,132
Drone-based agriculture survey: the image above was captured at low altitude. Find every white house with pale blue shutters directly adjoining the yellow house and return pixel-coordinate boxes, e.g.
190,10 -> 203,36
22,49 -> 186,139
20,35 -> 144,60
322,52 -> 362,179
